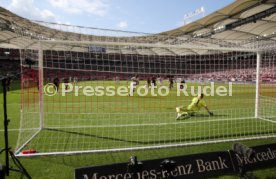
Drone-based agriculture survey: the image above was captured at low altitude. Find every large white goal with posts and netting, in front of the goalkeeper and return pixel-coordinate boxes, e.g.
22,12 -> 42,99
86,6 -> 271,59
16,24 -> 276,156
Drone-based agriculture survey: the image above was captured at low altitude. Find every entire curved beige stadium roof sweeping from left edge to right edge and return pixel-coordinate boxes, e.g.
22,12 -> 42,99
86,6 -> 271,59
0,0 -> 276,55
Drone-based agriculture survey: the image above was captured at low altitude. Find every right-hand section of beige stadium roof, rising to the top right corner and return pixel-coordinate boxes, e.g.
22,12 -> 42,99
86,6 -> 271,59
163,0 -> 276,40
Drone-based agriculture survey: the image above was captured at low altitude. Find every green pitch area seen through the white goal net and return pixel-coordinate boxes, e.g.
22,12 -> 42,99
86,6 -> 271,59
16,81 -> 276,153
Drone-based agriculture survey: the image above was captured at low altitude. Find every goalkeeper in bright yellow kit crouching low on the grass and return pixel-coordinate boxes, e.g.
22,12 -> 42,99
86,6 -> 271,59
176,93 -> 214,120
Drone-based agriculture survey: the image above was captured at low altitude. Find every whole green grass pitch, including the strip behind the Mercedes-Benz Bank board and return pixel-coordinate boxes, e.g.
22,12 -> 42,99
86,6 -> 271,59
0,81 -> 276,178
